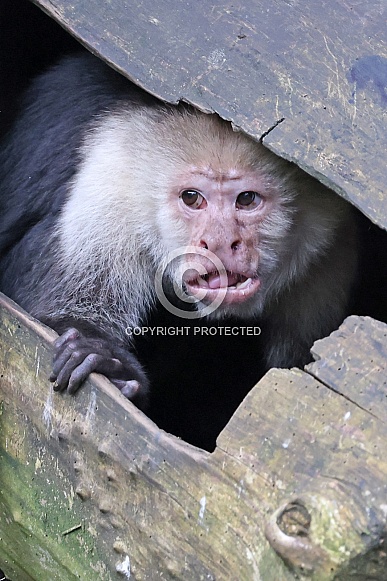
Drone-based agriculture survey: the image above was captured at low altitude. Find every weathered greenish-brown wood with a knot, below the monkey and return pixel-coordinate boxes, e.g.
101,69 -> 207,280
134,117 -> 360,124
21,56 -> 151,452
0,298 -> 387,581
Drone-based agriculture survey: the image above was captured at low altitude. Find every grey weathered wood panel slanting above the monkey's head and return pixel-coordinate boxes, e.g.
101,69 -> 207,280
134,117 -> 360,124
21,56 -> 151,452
33,0 -> 387,227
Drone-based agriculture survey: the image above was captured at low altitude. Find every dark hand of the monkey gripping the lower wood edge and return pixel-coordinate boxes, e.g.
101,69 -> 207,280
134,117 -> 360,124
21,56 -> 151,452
50,328 -> 148,408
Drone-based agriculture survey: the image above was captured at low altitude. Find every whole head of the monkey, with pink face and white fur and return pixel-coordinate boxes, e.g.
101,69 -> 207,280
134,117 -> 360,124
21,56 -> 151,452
58,103 -> 343,326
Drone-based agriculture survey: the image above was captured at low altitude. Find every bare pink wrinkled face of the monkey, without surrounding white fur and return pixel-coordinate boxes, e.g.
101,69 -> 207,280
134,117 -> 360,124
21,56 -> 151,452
164,167 -> 292,315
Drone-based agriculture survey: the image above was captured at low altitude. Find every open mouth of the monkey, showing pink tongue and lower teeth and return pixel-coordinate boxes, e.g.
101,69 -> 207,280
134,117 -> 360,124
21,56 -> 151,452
185,270 -> 261,304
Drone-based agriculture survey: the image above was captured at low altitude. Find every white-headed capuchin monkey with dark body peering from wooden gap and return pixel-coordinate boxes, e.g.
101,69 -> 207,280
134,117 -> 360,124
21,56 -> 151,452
0,54 -> 358,407
